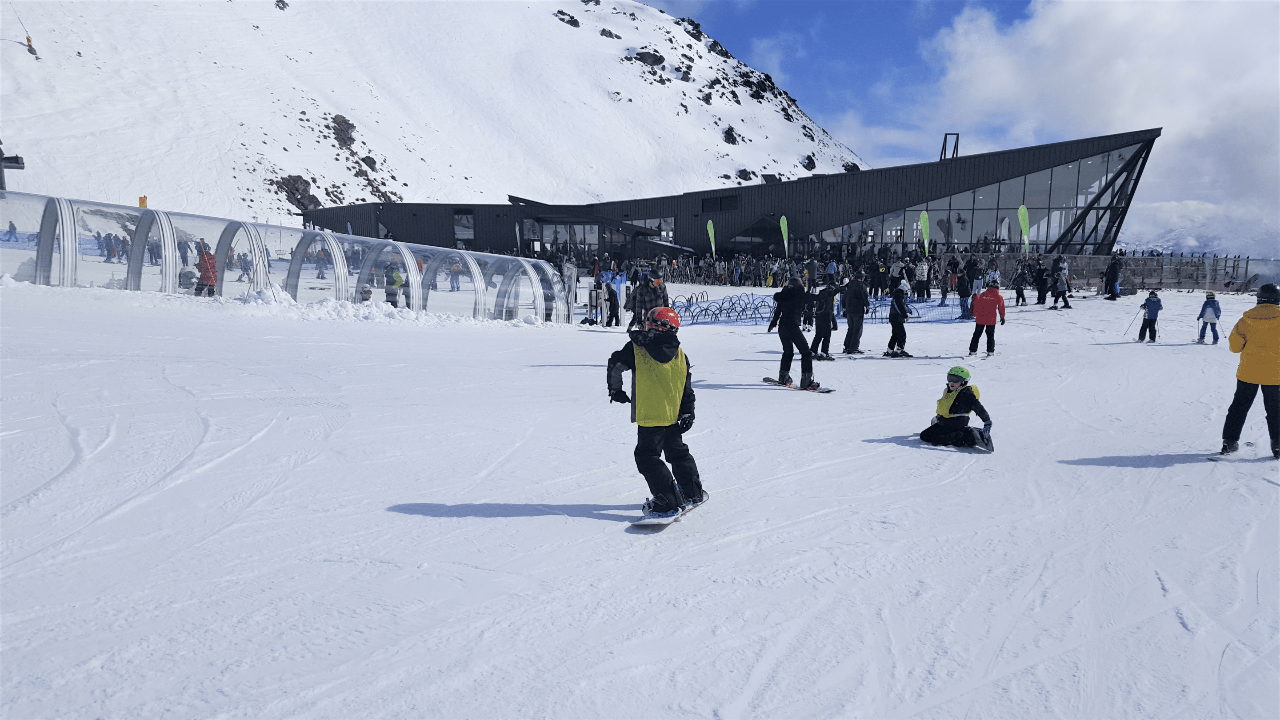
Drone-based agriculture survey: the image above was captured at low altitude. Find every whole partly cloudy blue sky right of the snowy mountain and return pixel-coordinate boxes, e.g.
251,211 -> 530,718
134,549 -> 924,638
649,0 -> 1280,258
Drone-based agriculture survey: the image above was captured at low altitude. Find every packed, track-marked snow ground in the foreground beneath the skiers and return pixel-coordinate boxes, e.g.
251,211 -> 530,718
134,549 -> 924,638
0,281 -> 1280,719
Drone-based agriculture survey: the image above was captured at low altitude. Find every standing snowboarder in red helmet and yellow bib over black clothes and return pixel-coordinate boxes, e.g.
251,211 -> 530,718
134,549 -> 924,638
608,302 -> 707,518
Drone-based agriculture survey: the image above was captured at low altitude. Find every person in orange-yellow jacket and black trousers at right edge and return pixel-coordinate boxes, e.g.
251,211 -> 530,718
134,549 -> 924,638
1220,283 -> 1280,460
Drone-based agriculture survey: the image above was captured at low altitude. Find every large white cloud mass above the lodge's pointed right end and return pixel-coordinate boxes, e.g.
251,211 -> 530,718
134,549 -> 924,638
833,0 -> 1280,256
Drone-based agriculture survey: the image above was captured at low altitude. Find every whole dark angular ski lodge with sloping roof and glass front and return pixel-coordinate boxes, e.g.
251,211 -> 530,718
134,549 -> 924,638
302,128 -> 1161,258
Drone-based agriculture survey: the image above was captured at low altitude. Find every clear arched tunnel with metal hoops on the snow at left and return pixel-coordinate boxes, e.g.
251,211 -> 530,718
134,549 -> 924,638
0,192 -> 572,323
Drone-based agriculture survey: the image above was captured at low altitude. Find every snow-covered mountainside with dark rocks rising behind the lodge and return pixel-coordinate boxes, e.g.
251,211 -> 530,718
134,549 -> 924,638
0,0 -> 860,219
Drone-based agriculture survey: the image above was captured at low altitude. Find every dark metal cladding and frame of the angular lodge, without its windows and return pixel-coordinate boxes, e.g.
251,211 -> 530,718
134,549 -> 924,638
302,128 -> 1161,255
